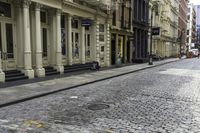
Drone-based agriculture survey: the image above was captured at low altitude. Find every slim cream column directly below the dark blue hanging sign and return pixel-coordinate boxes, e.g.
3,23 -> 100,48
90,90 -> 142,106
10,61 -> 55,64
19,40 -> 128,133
81,26 -> 85,64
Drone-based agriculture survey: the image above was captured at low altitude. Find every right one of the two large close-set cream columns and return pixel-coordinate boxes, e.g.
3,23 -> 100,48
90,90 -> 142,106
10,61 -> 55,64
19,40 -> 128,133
35,4 -> 45,77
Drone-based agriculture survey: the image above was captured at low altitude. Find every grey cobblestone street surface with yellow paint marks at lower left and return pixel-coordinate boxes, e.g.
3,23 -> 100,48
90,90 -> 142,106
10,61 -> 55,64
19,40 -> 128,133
0,59 -> 200,133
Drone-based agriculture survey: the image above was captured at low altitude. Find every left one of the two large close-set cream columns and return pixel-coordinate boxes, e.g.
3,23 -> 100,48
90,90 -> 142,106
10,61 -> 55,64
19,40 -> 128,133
23,0 -> 34,78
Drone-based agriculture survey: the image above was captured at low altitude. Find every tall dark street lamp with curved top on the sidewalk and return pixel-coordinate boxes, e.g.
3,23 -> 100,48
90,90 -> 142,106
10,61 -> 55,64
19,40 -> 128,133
149,3 -> 158,65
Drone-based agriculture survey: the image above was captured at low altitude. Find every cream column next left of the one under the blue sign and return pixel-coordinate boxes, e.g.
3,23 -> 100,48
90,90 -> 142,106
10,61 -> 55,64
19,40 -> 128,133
67,14 -> 72,65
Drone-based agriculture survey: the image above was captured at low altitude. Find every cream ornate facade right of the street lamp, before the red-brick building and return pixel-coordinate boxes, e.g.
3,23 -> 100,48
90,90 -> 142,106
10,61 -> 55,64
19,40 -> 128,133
150,0 -> 180,58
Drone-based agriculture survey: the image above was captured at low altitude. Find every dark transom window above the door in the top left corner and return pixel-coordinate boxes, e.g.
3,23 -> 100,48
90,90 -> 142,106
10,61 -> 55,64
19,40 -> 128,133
0,2 -> 11,18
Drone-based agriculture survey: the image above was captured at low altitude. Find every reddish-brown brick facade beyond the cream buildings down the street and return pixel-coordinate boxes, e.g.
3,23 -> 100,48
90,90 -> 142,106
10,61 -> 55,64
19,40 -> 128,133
178,0 -> 188,52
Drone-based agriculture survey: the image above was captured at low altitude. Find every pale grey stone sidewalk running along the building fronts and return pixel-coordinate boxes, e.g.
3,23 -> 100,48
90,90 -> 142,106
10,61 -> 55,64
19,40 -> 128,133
0,58 -> 180,107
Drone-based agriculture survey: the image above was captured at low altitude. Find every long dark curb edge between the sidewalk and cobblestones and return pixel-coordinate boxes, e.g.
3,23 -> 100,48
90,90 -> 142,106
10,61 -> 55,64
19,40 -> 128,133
0,59 -> 183,108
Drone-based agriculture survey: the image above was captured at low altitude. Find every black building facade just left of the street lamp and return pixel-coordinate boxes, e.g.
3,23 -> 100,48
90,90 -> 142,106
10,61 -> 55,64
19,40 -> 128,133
133,0 -> 149,62
